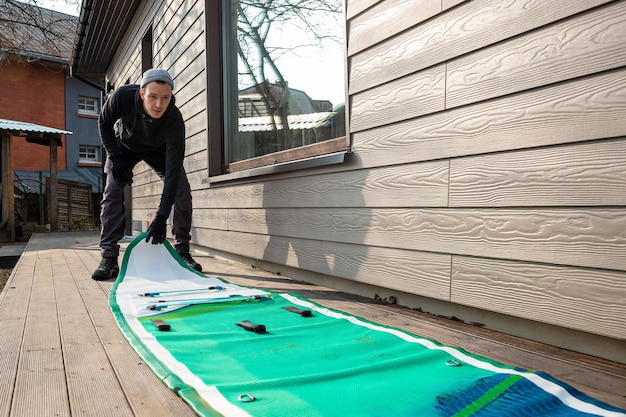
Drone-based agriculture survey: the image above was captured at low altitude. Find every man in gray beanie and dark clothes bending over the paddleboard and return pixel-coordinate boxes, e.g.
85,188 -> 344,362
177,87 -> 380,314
92,69 -> 202,280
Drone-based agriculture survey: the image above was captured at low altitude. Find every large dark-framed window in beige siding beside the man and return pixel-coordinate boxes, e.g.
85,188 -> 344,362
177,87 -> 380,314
207,0 -> 348,175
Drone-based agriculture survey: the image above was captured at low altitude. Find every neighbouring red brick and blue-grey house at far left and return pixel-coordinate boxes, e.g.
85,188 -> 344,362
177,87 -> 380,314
0,0 -> 103,228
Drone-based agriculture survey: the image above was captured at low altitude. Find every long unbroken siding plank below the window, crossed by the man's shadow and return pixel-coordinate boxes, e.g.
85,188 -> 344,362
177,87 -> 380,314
222,208 -> 626,270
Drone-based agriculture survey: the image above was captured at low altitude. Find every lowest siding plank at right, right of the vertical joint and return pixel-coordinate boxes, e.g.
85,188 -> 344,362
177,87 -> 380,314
451,256 -> 626,339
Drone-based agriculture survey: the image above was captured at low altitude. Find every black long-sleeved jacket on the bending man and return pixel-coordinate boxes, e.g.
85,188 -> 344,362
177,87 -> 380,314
98,84 -> 185,217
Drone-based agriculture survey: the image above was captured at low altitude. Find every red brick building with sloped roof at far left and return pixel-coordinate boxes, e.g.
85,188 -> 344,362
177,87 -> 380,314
0,0 -> 77,171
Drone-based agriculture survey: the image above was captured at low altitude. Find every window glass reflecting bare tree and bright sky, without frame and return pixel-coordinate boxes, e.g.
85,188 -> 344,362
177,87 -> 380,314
227,0 -> 345,162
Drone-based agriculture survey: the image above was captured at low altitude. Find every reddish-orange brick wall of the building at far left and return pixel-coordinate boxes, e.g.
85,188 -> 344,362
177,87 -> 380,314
0,61 -> 66,171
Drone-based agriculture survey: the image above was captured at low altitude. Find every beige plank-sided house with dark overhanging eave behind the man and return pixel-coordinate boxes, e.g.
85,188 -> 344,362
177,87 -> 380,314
72,0 -> 626,363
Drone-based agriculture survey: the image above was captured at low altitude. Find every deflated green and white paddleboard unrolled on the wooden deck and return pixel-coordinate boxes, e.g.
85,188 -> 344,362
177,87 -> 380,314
110,235 -> 626,417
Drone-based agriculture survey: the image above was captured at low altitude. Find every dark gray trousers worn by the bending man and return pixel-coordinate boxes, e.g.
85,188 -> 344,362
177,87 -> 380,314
100,149 -> 192,258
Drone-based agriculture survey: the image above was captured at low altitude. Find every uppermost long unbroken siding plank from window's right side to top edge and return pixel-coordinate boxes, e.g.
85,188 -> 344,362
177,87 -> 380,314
349,0 -> 609,94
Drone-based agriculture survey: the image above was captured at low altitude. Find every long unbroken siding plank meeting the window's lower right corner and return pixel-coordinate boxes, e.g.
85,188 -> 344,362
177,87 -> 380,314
352,69 -> 626,167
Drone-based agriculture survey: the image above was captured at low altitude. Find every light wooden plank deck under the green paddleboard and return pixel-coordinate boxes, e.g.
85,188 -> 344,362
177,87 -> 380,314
0,232 -> 626,417
